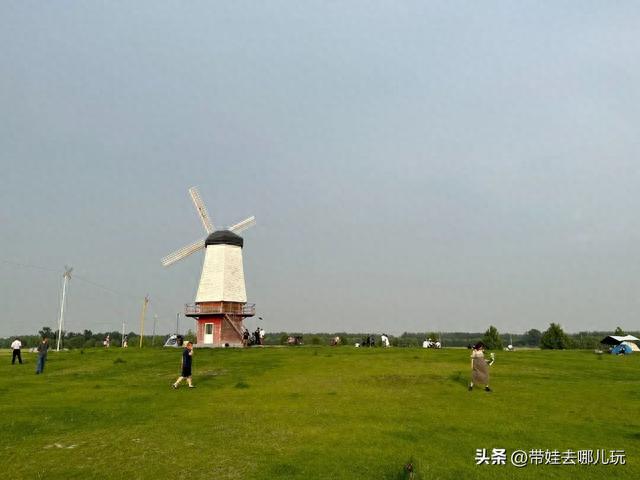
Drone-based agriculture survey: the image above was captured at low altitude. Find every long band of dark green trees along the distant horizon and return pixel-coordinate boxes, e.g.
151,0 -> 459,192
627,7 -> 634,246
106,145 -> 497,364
0,323 -> 640,350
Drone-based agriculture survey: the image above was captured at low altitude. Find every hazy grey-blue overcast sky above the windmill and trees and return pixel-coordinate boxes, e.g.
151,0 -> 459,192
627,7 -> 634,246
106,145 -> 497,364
0,0 -> 640,336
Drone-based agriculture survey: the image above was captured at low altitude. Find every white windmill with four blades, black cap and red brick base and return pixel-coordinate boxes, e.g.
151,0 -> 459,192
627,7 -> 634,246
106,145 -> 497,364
162,187 -> 256,347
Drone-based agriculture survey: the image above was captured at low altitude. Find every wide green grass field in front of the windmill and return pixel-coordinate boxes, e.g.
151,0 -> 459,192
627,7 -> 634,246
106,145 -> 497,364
0,347 -> 640,480
